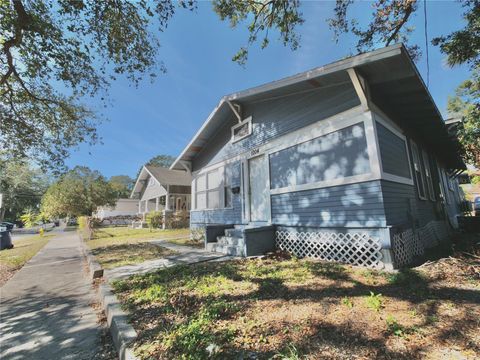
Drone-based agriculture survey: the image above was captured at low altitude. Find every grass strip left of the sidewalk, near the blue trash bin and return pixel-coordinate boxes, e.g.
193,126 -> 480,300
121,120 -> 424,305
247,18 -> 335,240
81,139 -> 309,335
0,234 -> 54,286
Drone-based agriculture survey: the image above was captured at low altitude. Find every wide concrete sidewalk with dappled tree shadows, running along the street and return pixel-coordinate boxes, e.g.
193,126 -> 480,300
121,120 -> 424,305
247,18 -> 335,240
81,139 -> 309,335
0,231 -> 107,360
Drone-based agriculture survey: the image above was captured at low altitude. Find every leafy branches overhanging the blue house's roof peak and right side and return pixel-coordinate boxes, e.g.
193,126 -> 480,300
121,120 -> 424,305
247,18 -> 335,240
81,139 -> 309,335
330,0 -> 480,166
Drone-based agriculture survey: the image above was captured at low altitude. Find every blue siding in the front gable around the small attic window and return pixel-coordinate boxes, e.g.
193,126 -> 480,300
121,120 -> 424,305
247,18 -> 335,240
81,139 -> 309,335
193,84 -> 360,171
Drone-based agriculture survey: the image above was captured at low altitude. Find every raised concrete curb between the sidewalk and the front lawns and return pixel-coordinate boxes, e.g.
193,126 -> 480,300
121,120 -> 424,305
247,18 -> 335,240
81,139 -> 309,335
79,235 -> 138,360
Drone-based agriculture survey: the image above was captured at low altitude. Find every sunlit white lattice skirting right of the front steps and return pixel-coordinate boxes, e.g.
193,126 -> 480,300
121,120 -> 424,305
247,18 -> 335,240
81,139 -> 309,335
275,230 -> 384,268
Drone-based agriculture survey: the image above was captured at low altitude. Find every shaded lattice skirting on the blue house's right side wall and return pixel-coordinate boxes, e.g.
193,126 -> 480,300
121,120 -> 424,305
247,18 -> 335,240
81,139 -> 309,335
392,221 -> 448,267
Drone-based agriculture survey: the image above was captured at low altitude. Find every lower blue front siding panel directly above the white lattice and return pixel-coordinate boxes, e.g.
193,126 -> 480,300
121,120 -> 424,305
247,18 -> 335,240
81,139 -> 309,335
271,181 -> 385,228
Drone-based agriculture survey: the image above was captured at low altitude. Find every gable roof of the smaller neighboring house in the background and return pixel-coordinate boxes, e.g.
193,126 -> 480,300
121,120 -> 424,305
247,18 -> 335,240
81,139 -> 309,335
130,165 -> 192,198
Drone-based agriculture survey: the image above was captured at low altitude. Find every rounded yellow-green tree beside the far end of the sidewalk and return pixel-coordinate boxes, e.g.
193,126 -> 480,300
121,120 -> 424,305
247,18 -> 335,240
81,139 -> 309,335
41,166 -> 117,219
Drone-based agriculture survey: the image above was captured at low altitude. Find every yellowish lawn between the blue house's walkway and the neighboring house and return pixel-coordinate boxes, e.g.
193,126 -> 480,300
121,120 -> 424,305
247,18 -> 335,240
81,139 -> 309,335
87,227 -> 190,269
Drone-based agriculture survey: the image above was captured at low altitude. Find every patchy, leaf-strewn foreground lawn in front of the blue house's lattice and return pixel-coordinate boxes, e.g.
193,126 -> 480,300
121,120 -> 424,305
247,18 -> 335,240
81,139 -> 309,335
114,239 -> 480,360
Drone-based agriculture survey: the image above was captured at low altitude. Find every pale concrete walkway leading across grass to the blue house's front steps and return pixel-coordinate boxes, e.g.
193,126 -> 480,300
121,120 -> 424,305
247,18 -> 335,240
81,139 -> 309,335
103,240 -> 234,281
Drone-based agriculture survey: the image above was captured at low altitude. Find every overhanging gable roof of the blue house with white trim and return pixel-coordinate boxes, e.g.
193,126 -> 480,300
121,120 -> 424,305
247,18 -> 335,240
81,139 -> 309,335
170,44 -> 465,169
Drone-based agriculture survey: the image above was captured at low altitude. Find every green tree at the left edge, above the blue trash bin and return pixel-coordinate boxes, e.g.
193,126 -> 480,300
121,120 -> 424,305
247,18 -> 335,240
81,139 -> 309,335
0,154 -> 49,221
